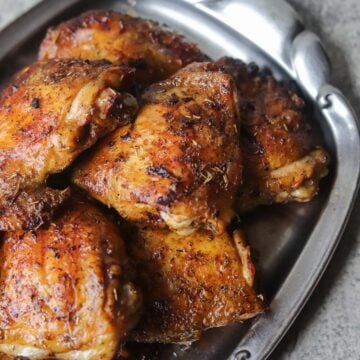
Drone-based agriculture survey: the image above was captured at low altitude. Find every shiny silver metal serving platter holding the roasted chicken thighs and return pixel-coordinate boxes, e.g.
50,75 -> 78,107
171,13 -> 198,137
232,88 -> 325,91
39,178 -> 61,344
0,0 -> 360,360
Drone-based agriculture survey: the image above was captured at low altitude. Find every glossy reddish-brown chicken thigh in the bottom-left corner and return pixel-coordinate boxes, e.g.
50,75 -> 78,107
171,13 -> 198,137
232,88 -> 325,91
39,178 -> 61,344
0,199 -> 141,360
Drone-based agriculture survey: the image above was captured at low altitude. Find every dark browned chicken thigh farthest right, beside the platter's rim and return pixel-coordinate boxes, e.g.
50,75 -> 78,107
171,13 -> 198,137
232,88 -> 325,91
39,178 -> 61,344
218,58 -> 329,212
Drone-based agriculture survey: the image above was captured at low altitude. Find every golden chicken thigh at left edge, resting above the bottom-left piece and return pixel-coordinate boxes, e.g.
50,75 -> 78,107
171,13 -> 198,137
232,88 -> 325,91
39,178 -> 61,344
0,60 -> 137,230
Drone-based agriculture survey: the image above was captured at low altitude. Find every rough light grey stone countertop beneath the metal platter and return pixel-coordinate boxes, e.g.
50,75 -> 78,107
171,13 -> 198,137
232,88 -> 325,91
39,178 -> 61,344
0,0 -> 360,360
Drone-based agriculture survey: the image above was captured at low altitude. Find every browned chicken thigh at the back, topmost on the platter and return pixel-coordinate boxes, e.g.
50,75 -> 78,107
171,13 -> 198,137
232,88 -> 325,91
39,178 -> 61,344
39,10 -> 208,86
